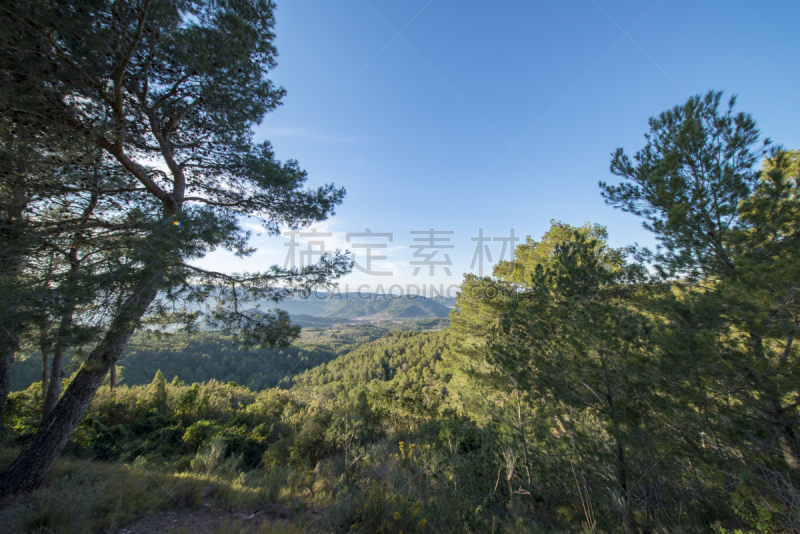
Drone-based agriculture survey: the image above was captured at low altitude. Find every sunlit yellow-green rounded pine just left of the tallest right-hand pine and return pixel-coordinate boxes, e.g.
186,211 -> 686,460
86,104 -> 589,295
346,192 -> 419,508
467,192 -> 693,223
453,222 -> 656,530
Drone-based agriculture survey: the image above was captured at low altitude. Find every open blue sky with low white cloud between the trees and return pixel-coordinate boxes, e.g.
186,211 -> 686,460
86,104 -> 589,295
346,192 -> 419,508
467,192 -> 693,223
202,0 -> 800,296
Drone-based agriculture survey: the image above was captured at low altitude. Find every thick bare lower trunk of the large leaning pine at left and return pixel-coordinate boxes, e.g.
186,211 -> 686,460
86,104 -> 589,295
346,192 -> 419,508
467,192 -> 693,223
0,276 -> 160,499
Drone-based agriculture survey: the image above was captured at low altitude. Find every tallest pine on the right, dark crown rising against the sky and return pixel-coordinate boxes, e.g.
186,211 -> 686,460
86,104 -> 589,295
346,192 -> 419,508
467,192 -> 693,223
600,92 -> 800,475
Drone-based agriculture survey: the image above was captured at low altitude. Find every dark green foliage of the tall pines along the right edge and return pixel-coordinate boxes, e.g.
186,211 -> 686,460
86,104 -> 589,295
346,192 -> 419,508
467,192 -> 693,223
601,92 -> 800,530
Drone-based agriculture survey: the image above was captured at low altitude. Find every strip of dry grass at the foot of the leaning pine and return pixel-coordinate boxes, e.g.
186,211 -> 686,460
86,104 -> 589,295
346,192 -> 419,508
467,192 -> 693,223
0,449 -> 350,534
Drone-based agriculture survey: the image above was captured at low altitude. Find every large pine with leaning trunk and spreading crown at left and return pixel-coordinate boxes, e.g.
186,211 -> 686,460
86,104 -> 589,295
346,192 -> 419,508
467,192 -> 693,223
0,0 -> 350,496
